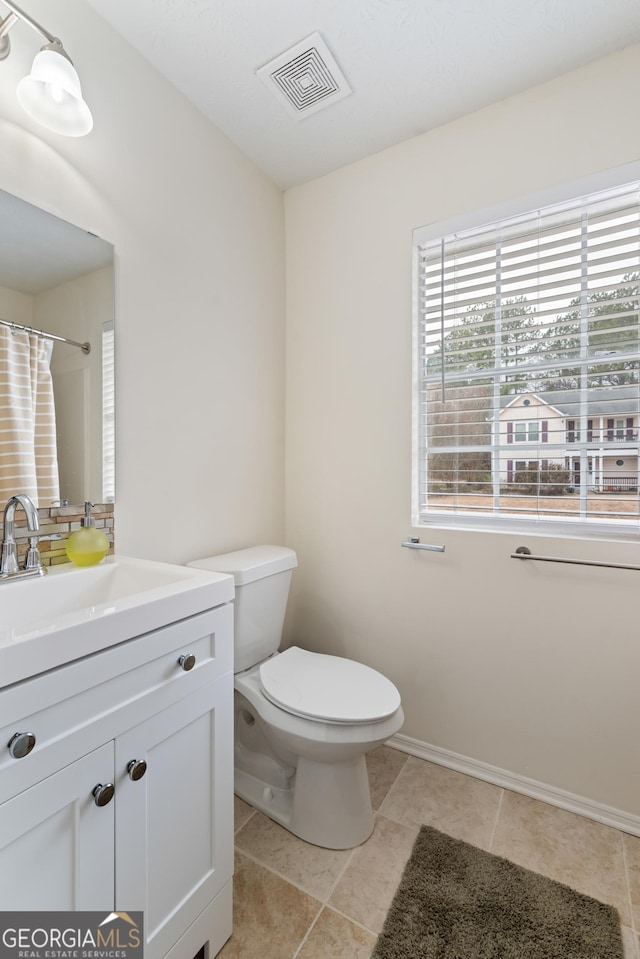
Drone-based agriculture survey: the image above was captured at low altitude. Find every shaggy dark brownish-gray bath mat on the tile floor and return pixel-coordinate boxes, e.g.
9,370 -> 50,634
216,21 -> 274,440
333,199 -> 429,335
372,826 -> 623,959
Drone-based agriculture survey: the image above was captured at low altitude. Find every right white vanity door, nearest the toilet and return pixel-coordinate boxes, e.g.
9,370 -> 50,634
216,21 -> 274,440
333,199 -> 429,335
115,673 -> 233,959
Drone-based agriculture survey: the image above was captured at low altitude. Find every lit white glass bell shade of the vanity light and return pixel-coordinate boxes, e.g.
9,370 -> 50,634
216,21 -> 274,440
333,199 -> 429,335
17,44 -> 93,137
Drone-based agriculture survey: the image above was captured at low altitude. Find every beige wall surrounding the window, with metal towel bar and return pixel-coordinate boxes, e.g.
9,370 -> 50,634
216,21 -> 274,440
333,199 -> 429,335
285,47 -> 640,816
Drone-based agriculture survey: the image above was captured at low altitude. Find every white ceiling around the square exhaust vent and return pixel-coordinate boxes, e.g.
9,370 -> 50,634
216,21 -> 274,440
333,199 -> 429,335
86,0 -> 640,189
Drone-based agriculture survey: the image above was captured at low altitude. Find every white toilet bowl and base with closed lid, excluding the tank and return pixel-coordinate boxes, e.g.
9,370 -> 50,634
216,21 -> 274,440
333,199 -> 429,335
235,647 -> 404,849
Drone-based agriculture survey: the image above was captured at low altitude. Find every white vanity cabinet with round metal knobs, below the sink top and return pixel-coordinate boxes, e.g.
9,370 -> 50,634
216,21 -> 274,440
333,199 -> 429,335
0,603 -> 233,959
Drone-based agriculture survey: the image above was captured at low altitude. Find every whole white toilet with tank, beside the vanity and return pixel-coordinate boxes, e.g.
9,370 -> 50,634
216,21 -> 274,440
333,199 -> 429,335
188,546 -> 404,849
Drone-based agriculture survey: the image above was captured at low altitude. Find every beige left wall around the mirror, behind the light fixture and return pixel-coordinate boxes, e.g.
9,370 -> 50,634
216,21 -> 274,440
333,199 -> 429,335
0,0 -> 284,562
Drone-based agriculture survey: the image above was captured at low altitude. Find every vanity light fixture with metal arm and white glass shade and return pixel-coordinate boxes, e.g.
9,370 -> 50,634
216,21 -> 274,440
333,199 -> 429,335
0,0 -> 93,137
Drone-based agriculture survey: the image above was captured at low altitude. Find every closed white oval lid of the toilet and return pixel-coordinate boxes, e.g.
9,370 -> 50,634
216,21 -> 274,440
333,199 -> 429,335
260,646 -> 400,723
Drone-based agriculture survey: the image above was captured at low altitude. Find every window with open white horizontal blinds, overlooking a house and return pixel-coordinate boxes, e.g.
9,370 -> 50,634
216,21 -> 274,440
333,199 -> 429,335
413,168 -> 640,532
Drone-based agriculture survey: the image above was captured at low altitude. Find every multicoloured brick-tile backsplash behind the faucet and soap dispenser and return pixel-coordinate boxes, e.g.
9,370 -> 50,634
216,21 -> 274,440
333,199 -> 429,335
0,503 -> 114,566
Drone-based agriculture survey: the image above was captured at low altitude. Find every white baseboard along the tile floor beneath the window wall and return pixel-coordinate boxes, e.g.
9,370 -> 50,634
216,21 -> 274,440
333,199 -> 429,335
387,735 -> 640,836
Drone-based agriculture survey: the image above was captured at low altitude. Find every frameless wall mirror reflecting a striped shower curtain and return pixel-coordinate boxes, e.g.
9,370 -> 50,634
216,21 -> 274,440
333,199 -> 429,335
0,191 -> 115,508
